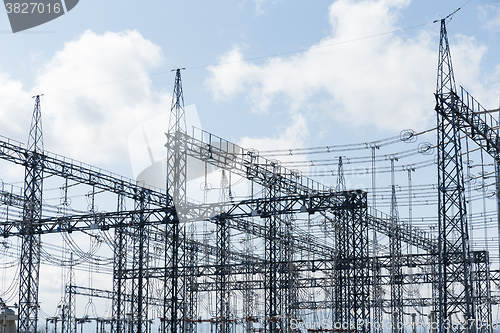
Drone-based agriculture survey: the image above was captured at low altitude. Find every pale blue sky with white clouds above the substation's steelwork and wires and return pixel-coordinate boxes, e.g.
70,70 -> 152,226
0,0 -> 500,176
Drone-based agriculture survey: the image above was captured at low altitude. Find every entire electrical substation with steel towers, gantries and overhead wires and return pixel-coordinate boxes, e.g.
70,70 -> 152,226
0,19 -> 500,333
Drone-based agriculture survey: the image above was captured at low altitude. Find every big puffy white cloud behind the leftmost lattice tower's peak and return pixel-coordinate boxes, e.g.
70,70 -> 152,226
0,31 -> 169,169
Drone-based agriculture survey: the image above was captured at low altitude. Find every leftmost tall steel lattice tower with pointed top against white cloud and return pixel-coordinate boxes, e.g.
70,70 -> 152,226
18,95 -> 43,333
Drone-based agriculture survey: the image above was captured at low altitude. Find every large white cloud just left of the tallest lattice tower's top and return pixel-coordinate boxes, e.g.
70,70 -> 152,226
205,0 -> 500,130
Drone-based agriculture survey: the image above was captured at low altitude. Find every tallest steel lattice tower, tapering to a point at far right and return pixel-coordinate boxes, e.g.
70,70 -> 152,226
434,19 -> 475,332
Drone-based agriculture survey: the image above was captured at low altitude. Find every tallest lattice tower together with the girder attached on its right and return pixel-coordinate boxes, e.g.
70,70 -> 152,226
434,19 -> 500,332
